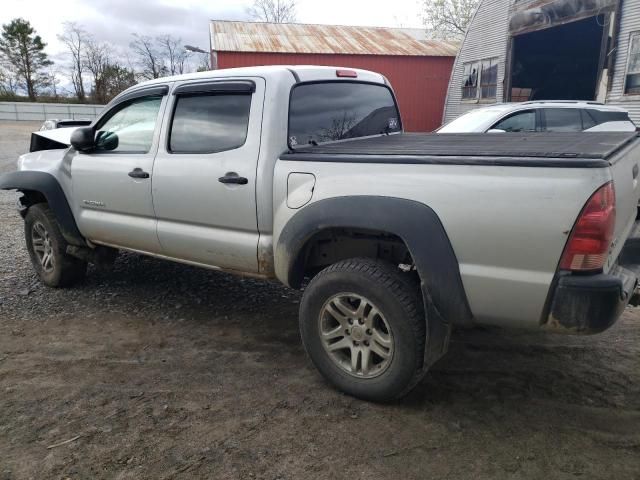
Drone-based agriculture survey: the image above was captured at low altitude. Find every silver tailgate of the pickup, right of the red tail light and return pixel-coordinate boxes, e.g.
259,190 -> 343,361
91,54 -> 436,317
607,140 -> 640,268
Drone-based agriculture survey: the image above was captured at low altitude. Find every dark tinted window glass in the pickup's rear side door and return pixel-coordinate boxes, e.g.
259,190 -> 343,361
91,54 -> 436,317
169,93 -> 251,153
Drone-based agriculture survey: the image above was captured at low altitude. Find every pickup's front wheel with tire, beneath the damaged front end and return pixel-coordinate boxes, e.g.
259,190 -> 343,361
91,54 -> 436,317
24,203 -> 87,288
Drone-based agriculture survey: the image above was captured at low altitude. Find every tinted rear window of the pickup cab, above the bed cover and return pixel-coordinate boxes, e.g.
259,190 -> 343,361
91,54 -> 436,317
289,81 -> 402,147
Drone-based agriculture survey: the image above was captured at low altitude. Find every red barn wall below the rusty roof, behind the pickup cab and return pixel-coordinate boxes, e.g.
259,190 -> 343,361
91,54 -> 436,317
218,52 -> 454,132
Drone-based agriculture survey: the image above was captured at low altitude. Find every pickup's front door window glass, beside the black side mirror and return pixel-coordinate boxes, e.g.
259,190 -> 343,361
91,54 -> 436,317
95,97 -> 162,153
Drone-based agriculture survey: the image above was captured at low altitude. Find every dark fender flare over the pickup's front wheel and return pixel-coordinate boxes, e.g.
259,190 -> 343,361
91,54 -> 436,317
0,171 -> 87,247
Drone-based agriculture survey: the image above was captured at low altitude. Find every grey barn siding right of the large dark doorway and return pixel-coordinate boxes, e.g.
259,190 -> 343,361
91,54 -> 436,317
607,0 -> 640,125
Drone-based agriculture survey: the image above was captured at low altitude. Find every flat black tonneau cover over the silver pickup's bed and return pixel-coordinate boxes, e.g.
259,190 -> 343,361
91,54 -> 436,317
282,132 -> 638,168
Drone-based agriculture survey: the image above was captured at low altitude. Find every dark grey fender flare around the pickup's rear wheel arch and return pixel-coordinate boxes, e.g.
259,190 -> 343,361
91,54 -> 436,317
275,196 -> 473,366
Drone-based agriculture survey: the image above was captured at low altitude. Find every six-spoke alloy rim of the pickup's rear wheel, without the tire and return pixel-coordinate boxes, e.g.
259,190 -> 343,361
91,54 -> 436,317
318,293 -> 394,378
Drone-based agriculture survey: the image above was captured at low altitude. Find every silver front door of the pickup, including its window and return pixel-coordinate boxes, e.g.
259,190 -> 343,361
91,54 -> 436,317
71,87 -> 167,253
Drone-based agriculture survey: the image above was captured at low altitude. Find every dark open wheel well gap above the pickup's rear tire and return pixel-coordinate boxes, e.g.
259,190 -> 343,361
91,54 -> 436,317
295,228 -> 413,283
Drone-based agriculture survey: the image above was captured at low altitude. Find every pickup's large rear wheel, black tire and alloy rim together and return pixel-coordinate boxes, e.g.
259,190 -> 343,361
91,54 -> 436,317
300,258 -> 426,402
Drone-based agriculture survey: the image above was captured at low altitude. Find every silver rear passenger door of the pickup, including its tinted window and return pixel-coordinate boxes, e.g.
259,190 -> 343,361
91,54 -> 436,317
153,78 -> 265,272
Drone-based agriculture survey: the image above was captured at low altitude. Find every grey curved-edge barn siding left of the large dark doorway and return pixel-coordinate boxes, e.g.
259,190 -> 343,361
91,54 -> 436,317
444,0 -> 510,123
